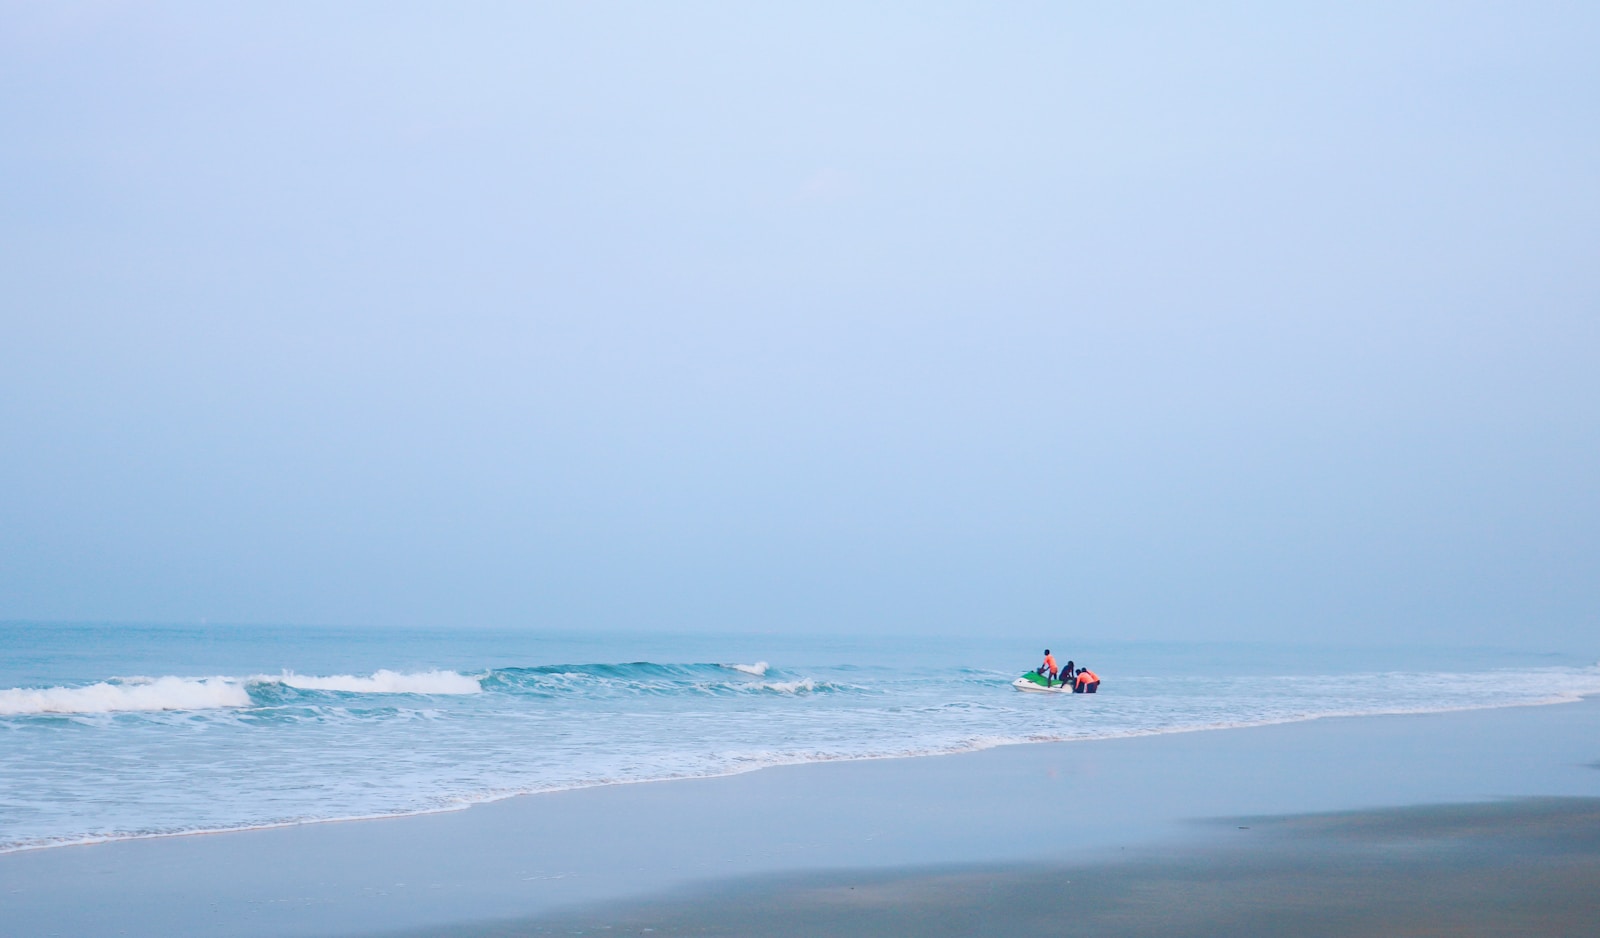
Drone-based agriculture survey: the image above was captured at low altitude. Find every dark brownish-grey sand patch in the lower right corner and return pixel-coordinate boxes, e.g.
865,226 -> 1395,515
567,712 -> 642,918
470,799 -> 1600,938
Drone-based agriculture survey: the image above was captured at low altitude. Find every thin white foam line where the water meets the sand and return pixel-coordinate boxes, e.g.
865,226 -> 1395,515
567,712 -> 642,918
0,685 -> 1600,856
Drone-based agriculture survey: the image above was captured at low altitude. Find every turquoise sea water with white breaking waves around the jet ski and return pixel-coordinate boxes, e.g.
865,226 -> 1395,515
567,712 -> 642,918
0,624 -> 1600,852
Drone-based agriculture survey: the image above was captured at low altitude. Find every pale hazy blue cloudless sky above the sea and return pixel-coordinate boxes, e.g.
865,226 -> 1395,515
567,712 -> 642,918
0,2 -> 1600,651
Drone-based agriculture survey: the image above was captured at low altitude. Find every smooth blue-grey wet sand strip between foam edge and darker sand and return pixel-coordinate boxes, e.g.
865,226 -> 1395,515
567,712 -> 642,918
0,698 -> 1600,938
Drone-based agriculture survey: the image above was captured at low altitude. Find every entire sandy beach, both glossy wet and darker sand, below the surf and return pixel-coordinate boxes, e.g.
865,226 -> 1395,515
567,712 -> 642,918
0,699 -> 1600,936
